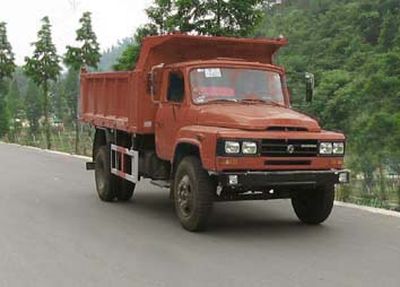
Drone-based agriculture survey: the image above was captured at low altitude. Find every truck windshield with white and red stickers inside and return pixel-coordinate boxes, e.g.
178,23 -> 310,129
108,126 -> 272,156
190,68 -> 285,105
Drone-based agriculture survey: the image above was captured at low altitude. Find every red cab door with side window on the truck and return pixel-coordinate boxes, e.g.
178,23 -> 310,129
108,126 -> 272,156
155,71 -> 186,160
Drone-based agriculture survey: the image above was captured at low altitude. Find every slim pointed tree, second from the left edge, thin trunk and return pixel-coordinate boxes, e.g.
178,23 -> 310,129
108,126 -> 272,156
24,16 -> 61,149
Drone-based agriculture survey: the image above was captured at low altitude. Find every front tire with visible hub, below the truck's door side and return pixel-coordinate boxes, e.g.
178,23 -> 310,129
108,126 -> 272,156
174,156 -> 216,231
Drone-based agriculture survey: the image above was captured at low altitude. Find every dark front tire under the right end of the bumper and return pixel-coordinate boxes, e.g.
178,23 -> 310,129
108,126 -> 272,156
292,184 -> 335,224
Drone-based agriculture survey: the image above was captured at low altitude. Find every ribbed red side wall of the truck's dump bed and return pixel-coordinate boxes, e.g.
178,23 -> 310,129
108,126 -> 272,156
79,71 -> 154,134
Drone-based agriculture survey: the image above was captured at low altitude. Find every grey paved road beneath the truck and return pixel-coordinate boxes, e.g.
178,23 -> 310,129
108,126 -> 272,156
0,144 -> 400,287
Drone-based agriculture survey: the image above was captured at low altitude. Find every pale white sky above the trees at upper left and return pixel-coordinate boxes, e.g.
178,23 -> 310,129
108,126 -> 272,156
0,0 -> 152,65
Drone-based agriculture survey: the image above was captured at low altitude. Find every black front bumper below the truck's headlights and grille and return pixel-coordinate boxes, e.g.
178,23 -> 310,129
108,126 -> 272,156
218,170 -> 350,189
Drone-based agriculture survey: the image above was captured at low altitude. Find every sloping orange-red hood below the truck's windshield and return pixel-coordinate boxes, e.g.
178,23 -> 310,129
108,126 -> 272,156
197,103 -> 321,132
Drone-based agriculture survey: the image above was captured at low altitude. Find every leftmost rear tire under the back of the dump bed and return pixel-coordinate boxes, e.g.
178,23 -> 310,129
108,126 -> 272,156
94,146 -> 117,202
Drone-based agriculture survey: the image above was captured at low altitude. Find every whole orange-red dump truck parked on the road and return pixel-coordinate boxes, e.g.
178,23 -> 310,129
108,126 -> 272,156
79,34 -> 349,231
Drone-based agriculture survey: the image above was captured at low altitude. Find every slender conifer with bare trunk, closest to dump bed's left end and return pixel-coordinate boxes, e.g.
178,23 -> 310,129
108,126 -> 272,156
64,12 -> 101,153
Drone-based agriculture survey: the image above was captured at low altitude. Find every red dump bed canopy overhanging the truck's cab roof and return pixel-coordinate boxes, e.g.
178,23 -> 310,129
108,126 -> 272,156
136,34 -> 287,70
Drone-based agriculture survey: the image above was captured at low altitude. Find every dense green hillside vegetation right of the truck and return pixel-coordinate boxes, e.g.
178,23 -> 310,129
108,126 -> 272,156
256,0 -> 400,205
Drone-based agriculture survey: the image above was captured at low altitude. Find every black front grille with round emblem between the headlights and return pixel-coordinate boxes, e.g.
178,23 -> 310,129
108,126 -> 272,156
261,139 -> 318,157
